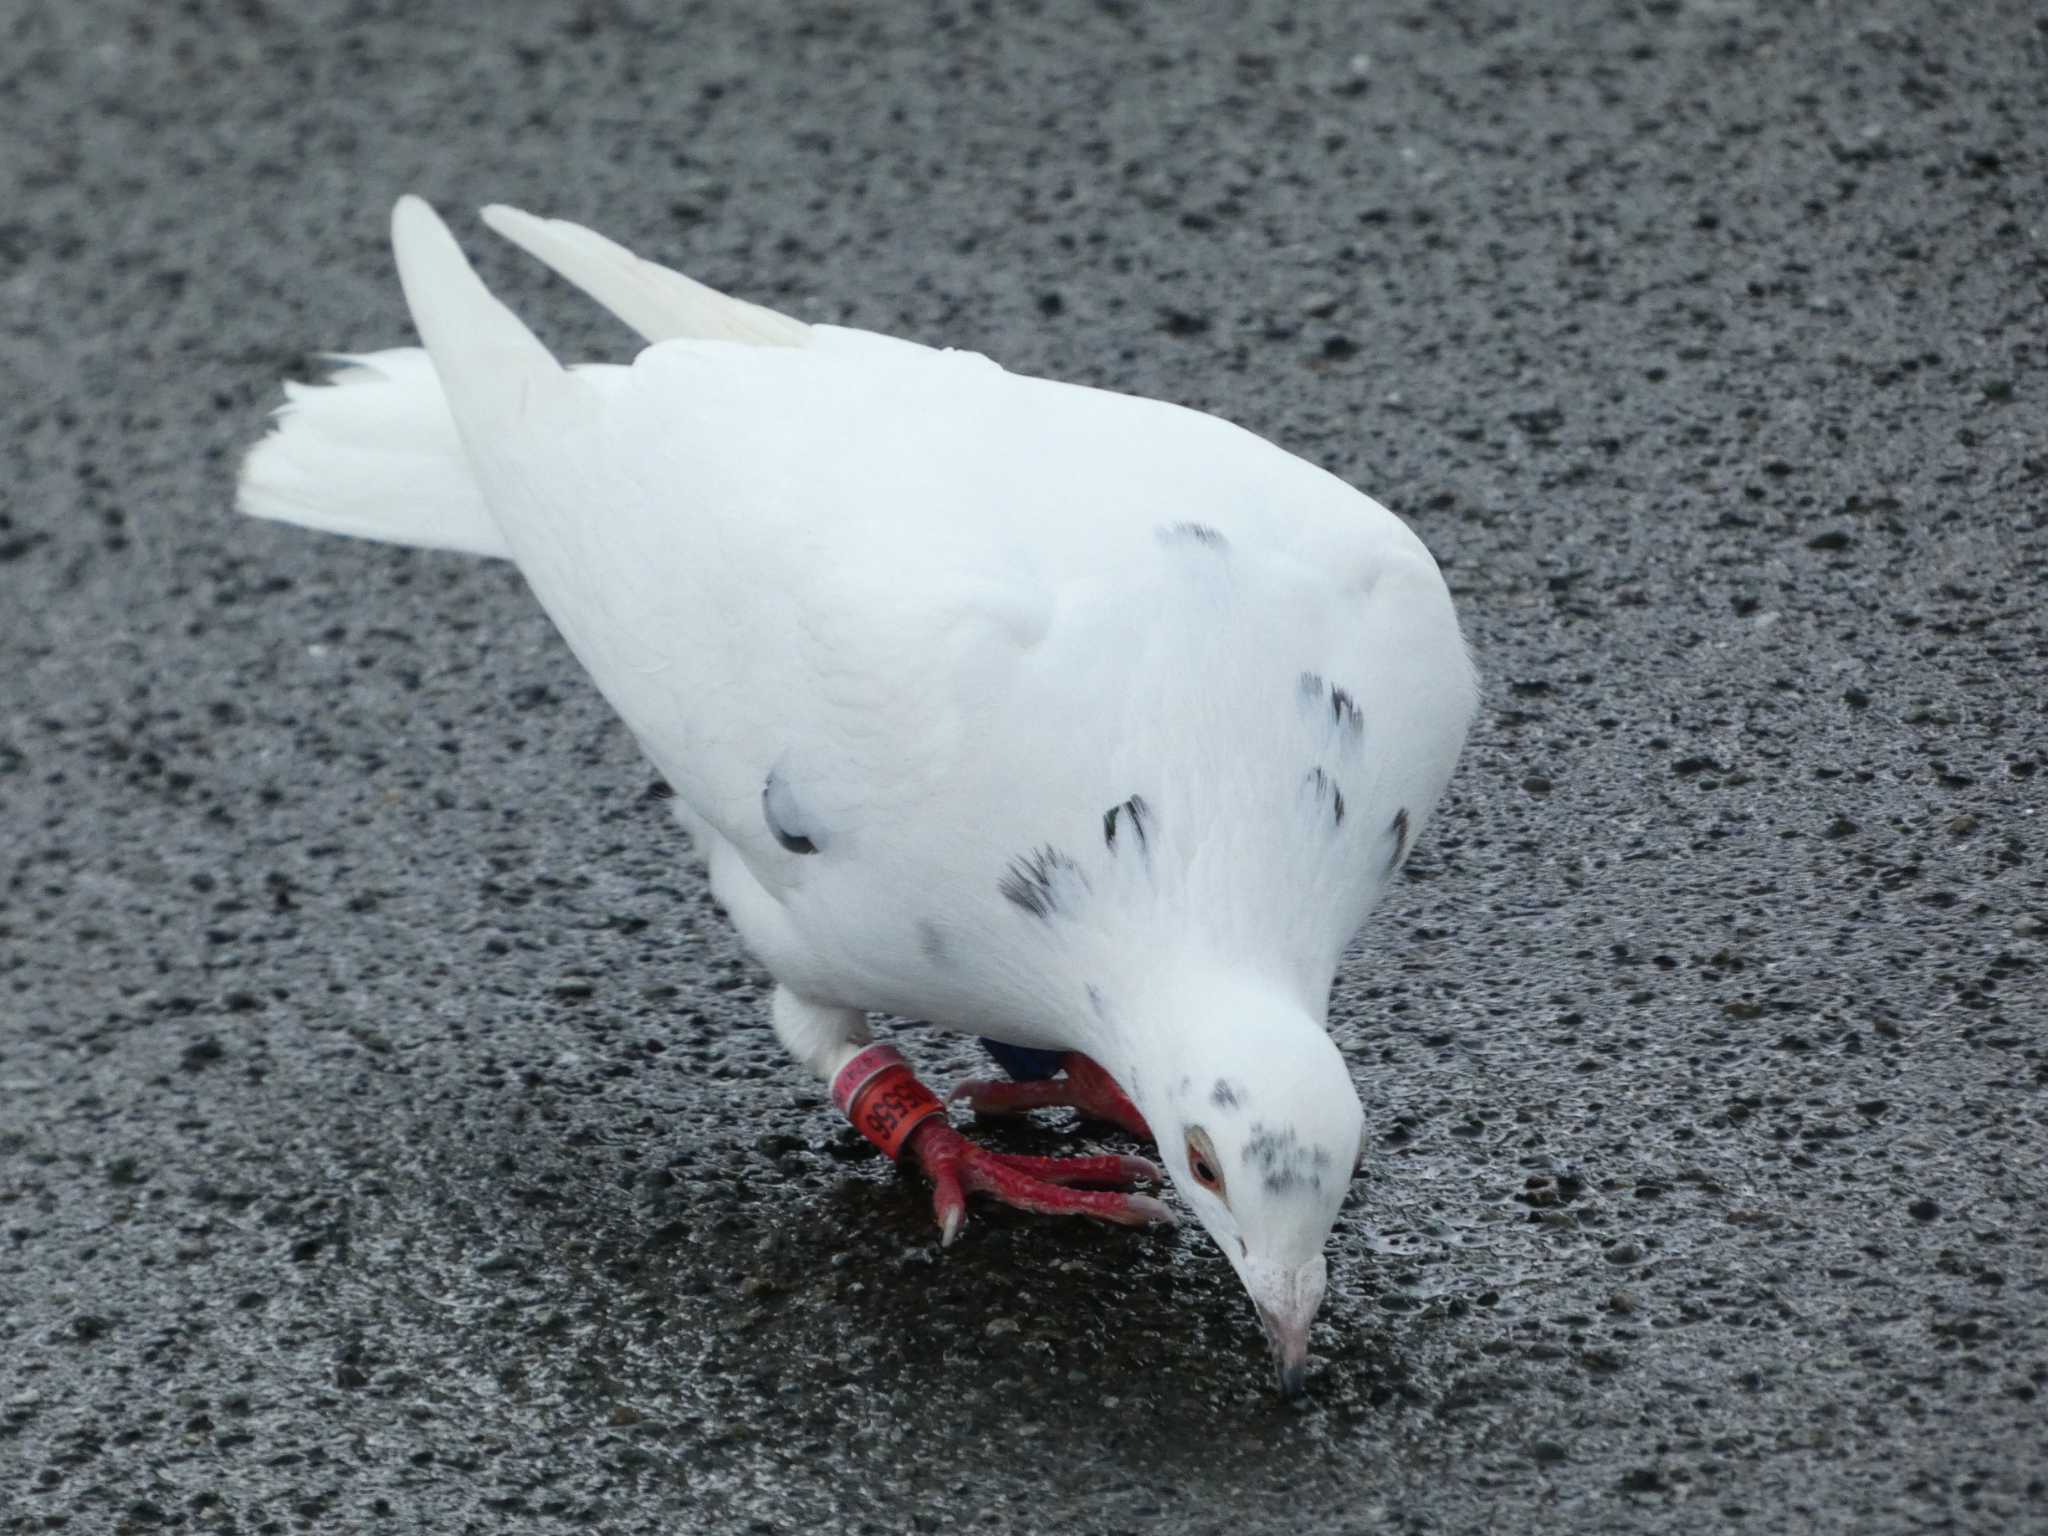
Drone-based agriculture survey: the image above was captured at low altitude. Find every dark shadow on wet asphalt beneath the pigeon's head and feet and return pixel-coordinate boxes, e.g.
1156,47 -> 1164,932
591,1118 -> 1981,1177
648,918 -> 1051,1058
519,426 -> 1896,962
638,1126 -> 1458,1479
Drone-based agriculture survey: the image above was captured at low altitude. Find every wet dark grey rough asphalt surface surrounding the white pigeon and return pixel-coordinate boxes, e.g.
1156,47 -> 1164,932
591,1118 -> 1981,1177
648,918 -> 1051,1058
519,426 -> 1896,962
0,0 -> 2048,1536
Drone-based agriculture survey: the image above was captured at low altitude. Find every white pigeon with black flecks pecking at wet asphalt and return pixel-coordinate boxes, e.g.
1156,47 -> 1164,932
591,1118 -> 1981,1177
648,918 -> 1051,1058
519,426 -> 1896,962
240,197 -> 1477,1393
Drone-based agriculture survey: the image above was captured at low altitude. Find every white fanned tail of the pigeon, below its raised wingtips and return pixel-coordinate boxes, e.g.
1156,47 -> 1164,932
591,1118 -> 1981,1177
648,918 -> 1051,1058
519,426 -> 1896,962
236,346 -> 510,557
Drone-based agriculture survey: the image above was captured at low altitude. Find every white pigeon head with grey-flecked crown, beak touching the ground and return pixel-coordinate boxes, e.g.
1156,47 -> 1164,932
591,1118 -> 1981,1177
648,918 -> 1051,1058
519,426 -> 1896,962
1135,989 -> 1364,1397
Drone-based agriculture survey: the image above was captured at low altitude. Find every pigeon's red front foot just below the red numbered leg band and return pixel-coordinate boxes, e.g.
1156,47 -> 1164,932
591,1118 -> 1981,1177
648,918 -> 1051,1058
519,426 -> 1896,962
903,1118 -> 1176,1247
